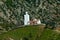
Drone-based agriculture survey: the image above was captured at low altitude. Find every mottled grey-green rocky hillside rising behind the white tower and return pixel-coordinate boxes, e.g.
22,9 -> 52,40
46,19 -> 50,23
0,0 -> 60,26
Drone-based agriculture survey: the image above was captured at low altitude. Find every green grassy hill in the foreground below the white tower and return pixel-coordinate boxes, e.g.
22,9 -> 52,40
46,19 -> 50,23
0,26 -> 60,40
